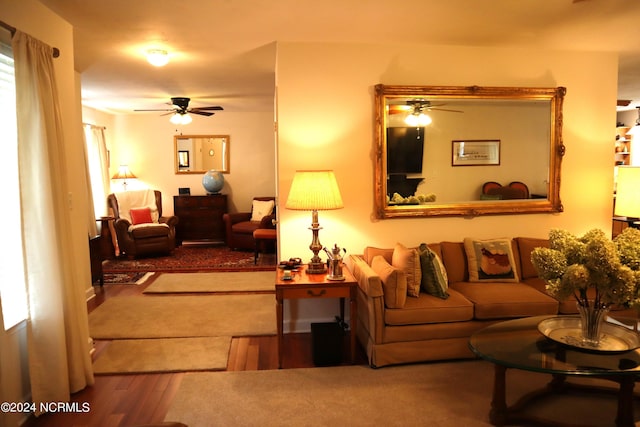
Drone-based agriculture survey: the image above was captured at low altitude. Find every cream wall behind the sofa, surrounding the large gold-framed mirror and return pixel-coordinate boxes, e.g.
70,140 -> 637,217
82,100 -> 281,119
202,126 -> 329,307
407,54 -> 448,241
276,43 -> 617,329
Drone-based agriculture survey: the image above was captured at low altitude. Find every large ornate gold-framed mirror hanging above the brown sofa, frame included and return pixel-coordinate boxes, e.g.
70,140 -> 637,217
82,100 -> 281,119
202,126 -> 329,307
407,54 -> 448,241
374,85 -> 566,219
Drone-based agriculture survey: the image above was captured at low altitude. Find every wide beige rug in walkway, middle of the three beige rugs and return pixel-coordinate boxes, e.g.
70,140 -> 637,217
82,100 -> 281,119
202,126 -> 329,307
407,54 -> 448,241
89,294 -> 277,339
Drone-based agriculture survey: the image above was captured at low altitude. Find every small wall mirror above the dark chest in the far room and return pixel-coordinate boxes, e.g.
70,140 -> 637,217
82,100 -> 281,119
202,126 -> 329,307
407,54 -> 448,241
173,135 -> 230,174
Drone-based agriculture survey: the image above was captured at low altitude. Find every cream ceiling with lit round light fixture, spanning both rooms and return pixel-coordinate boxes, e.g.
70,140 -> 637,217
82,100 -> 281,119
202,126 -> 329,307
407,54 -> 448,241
40,0 -> 640,114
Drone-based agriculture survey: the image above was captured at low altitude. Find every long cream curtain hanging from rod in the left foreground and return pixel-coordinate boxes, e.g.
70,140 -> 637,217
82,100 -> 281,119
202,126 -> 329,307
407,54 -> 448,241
13,31 -> 94,414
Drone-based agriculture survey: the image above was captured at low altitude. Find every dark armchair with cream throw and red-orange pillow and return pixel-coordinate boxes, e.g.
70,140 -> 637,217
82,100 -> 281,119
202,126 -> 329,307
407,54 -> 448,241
107,190 -> 178,259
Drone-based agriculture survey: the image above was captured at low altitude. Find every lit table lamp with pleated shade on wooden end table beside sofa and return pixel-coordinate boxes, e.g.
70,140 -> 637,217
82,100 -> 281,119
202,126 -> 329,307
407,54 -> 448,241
285,170 -> 344,274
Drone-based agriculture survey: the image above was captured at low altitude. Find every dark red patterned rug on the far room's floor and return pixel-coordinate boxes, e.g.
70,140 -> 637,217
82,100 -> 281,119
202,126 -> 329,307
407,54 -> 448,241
102,246 -> 276,273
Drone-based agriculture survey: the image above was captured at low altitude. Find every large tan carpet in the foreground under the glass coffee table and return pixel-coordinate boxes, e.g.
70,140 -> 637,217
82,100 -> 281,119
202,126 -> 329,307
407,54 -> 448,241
165,361 -> 640,427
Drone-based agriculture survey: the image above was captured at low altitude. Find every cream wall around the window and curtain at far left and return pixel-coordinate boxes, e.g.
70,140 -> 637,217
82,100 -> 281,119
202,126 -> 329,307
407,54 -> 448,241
0,0 -> 86,426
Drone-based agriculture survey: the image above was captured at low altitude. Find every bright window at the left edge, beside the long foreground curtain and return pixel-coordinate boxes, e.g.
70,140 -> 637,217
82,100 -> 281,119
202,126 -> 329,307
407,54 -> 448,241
0,29 -> 27,330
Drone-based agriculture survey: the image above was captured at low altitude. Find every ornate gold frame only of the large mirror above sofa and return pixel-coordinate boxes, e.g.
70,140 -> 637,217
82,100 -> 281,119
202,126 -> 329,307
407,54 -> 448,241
374,84 -> 566,219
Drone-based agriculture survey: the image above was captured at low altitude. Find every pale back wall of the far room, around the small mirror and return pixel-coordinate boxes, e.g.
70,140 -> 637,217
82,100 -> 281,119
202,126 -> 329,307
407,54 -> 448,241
83,108 -> 276,215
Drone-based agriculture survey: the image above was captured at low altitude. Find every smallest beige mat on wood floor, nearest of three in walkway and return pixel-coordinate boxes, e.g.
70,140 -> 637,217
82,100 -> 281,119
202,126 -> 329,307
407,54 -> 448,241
93,337 -> 231,374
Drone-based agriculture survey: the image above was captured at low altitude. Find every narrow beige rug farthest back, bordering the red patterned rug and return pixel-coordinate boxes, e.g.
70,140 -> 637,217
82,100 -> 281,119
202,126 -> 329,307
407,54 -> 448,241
144,271 -> 276,294
